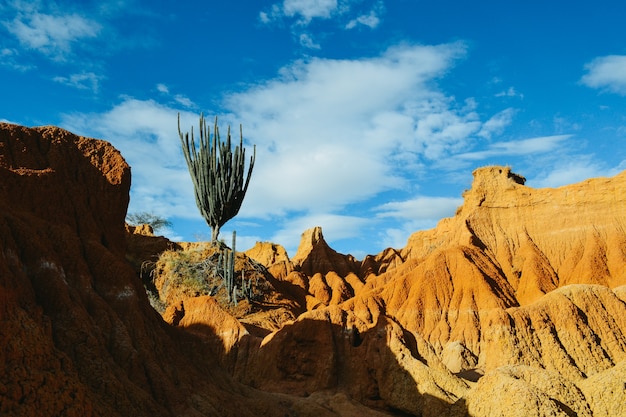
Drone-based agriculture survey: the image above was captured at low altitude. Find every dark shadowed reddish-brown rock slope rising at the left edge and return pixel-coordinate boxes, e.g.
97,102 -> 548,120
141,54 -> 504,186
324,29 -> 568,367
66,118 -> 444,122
0,123 -> 356,417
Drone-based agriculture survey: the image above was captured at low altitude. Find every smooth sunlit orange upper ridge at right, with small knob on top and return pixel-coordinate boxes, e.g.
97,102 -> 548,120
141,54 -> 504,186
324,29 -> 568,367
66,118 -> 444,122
402,167 -> 626,304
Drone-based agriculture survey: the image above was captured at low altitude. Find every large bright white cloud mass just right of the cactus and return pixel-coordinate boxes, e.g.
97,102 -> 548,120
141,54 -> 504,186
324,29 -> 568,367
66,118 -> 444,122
225,44 -> 470,216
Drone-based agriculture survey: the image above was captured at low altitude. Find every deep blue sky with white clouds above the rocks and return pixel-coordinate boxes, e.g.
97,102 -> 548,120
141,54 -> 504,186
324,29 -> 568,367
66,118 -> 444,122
0,0 -> 626,259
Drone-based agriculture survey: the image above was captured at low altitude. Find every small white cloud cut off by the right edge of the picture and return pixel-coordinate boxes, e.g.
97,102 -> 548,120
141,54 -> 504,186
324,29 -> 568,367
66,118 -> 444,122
580,55 -> 626,95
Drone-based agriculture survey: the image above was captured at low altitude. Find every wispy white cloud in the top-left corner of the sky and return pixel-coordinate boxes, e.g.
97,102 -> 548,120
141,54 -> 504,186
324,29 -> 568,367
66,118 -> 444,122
3,12 -> 101,59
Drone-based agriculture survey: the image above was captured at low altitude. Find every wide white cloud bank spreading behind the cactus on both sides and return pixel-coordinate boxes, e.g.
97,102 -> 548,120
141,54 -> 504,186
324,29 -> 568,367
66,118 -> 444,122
62,43 -> 528,255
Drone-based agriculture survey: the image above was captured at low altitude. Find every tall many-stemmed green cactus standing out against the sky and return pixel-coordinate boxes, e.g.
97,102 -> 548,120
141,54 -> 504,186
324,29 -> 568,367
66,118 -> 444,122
178,113 -> 256,242
